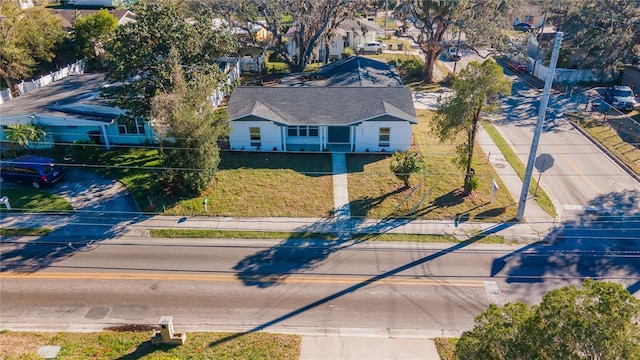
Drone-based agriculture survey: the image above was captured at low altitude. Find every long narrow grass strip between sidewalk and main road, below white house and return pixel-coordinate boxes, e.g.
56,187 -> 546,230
151,229 -> 504,244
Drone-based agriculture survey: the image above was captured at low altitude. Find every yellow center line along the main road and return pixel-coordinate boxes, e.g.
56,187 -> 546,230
0,272 -> 485,287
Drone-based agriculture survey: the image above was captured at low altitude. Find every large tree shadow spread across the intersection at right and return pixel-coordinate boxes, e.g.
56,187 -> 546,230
491,190 -> 640,293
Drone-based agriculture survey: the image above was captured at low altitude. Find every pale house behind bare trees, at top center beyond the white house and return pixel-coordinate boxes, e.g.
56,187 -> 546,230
286,18 -> 384,61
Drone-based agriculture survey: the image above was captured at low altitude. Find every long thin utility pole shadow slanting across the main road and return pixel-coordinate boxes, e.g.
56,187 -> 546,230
215,223 -> 513,347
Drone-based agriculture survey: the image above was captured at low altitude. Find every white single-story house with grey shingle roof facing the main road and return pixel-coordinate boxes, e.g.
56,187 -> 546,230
227,86 -> 417,152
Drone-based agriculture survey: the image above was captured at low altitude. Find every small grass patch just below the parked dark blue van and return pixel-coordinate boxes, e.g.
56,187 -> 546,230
0,185 -> 73,212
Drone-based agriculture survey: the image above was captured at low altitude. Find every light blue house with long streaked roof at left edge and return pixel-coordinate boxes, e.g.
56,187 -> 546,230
0,73 -> 154,149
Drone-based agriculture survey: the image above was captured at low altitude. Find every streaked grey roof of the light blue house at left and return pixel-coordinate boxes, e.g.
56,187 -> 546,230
0,73 -> 122,124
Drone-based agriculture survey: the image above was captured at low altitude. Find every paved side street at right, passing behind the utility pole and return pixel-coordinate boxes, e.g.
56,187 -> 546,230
495,77 -> 640,222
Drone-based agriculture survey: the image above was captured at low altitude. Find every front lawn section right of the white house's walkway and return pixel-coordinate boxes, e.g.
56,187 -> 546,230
347,110 -> 516,222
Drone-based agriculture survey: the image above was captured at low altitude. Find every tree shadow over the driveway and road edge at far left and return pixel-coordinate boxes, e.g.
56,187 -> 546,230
0,170 -> 147,272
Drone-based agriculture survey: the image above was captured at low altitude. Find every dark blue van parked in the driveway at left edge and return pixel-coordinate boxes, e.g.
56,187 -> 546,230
0,155 -> 64,189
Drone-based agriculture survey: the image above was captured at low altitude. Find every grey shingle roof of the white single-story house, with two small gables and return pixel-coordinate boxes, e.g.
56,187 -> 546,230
227,86 -> 417,125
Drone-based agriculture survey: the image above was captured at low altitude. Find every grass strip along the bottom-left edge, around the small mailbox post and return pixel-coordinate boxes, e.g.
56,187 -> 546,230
0,328 -> 300,360
